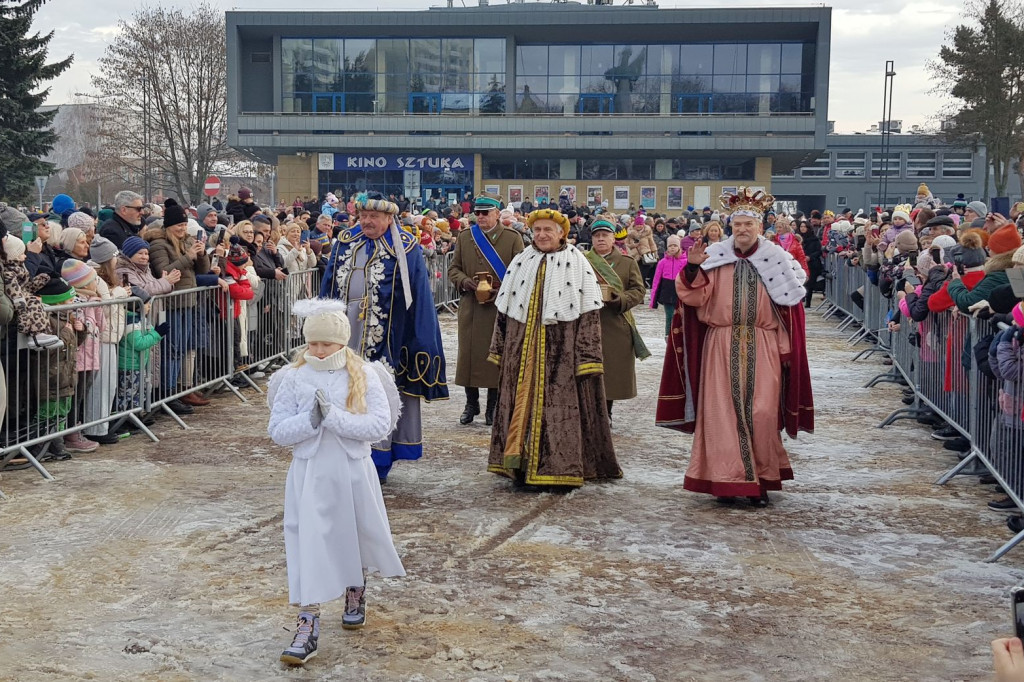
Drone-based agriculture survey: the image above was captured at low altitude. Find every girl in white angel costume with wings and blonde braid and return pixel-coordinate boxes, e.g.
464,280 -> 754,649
267,299 -> 406,666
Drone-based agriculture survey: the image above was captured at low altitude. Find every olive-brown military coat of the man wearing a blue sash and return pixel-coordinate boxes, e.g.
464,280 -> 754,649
449,225 -> 523,388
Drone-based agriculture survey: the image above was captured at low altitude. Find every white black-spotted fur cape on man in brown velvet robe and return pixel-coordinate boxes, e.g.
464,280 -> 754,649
495,244 -> 602,326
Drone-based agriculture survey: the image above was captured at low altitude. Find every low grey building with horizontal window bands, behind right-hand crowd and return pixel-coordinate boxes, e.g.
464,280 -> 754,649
772,133 -> 988,213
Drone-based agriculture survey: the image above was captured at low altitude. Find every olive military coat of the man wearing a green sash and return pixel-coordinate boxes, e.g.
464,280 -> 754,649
598,249 -> 647,400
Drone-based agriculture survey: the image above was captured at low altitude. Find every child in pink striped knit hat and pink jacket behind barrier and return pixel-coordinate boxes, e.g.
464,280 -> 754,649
60,254 -> 105,453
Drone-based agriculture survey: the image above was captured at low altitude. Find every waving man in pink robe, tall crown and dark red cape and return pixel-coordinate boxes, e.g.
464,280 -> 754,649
656,187 -> 814,507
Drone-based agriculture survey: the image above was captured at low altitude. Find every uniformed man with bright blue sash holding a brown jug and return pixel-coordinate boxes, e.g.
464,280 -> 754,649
449,195 -> 523,426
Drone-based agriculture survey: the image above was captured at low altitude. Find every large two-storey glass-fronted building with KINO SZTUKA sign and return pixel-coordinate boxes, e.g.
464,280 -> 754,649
226,2 -> 831,211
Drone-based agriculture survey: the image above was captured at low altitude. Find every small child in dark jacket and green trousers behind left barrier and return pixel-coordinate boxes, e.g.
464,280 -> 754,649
31,278 -> 87,459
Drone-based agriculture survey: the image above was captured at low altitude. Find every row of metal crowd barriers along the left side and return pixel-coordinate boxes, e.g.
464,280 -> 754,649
0,258 -> 459,499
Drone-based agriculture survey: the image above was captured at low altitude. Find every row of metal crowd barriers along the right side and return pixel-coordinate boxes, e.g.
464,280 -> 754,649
819,254 -> 1024,561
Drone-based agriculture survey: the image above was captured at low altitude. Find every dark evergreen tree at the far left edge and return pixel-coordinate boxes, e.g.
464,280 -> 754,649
0,0 -> 72,200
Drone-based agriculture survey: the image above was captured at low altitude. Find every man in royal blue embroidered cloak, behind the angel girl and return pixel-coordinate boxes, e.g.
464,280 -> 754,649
321,188 -> 447,482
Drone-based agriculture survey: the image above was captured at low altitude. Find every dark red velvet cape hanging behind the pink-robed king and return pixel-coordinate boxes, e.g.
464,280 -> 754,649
654,284 -> 814,437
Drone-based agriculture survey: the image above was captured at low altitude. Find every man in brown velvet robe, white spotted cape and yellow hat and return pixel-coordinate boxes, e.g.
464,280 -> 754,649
487,209 -> 623,487
